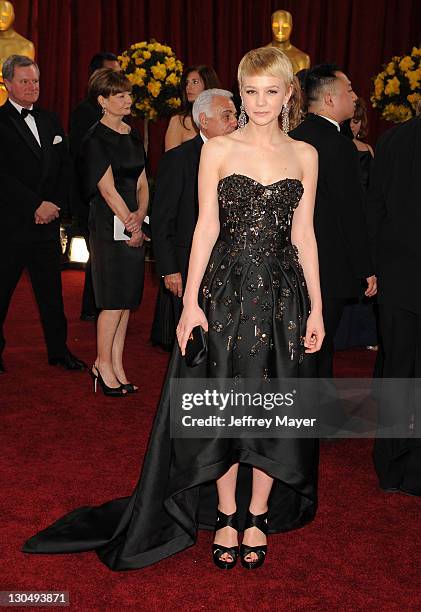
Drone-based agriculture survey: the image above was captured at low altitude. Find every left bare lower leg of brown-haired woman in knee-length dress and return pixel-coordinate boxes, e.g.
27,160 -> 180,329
95,310 -> 124,387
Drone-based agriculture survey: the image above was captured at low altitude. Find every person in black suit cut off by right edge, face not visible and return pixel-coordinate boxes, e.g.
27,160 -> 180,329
367,104 -> 421,495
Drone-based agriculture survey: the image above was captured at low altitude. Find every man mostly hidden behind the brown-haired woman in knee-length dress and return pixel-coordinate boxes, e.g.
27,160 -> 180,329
69,51 -> 121,321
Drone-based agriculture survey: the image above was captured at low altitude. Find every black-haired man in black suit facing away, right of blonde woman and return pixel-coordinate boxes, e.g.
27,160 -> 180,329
290,64 -> 376,378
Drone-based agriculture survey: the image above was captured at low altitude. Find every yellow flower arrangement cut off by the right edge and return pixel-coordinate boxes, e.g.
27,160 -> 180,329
370,47 -> 421,123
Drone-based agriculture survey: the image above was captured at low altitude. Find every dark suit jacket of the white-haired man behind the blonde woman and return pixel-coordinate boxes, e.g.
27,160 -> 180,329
151,134 -> 203,279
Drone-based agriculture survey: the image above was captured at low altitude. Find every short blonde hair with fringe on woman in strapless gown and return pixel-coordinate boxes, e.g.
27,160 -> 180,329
237,47 -> 294,89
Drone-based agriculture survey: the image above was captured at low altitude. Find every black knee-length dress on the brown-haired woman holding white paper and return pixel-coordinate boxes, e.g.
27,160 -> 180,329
78,122 -> 146,310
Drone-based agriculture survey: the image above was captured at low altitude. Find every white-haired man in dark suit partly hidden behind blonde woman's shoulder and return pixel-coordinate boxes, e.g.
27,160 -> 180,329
151,89 -> 237,324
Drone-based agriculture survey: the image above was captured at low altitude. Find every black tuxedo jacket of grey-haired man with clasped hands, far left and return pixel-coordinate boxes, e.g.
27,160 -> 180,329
0,102 -> 70,242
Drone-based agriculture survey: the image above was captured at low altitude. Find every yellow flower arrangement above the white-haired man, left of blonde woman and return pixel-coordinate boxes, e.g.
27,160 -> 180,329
118,39 -> 183,121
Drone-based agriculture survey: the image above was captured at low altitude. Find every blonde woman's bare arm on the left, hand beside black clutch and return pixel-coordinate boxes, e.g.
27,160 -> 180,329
177,138 -> 223,355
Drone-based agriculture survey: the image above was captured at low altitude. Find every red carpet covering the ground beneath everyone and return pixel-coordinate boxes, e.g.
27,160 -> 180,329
0,271 -> 421,612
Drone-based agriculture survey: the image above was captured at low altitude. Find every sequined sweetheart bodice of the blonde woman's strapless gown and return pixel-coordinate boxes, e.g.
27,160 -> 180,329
218,174 -> 304,257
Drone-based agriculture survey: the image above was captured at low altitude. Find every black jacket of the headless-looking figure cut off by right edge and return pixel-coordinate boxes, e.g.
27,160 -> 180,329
367,117 -> 421,313
